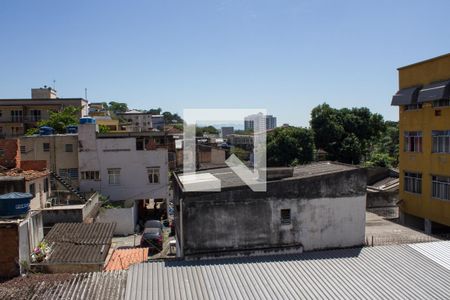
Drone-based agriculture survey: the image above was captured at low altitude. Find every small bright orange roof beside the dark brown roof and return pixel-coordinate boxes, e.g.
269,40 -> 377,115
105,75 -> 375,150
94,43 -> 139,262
105,248 -> 148,271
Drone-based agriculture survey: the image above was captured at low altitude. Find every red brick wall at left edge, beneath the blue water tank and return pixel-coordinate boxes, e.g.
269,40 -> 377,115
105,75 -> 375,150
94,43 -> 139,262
0,224 -> 20,277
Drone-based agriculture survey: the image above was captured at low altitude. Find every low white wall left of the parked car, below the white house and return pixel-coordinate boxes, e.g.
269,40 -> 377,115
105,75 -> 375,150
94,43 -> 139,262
95,205 -> 138,235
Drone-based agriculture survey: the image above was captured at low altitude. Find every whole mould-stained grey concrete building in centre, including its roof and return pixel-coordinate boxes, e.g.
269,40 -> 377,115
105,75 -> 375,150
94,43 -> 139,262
174,162 -> 366,259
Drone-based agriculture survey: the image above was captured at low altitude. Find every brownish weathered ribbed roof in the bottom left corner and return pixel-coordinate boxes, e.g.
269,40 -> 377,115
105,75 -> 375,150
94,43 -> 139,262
0,271 -> 127,300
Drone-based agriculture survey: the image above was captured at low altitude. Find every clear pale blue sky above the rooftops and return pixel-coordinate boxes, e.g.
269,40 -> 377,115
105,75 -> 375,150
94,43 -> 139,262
0,0 -> 450,126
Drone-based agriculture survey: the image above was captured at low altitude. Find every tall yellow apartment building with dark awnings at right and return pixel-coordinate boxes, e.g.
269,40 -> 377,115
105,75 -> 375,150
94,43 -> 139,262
392,53 -> 450,233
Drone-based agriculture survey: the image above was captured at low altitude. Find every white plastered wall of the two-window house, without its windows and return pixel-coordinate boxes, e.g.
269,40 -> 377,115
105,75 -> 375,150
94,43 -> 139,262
78,124 -> 168,201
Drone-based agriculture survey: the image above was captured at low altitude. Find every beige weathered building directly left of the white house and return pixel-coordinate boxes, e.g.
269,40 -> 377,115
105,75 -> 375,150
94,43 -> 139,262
19,133 -> 79,188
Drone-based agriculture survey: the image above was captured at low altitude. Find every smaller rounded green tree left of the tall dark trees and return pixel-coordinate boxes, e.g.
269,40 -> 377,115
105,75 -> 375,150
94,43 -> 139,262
267,127 -> 314,167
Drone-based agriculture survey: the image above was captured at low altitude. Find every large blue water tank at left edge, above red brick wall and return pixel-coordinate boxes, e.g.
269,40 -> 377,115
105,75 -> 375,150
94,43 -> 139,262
0,192 -> 33,217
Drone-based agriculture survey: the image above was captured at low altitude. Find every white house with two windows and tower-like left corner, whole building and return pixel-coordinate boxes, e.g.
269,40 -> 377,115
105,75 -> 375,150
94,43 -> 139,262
78,124 -> 168,201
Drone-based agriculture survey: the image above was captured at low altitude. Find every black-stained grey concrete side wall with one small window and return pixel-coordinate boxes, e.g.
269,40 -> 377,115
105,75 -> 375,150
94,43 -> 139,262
175,169 -> 366,257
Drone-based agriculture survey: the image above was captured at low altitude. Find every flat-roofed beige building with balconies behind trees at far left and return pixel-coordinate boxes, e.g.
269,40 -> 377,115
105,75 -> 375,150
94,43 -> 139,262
0,87 -> 88,138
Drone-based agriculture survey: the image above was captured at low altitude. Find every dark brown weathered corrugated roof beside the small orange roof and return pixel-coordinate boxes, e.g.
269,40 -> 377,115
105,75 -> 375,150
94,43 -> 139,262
45,223 -> 115,263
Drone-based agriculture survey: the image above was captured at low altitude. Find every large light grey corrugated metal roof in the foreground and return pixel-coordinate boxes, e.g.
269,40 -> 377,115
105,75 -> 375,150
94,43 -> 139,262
125,244 -> 450,300
